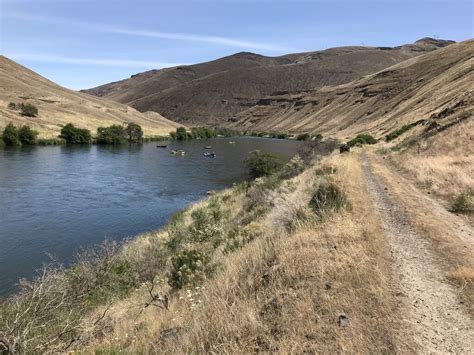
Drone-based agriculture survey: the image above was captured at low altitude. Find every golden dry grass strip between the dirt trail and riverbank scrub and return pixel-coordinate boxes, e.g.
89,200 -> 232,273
82,153 -> 397,353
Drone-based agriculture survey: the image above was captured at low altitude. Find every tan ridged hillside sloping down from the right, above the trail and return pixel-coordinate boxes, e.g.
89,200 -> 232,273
234,40 -> 474,137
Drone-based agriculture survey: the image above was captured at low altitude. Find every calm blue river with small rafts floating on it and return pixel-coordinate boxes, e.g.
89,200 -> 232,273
0,137 -> 302,297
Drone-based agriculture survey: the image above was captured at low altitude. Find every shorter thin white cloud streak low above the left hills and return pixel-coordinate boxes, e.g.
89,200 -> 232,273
4,53 -> 183,69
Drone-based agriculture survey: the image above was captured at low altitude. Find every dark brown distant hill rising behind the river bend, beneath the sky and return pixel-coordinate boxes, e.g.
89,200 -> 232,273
85,38 -> 452,124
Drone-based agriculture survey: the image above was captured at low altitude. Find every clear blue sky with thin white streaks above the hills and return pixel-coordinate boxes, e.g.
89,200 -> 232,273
0,0 -> 474,90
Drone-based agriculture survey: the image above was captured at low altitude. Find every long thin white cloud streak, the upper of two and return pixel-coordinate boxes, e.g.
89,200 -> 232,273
3,13 -> 290,52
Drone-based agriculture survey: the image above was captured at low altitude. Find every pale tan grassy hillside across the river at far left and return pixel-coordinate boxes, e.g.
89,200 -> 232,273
0,56 -> 177,137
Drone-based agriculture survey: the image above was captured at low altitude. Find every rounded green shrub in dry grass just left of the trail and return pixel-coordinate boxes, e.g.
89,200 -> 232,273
309,182 -> 349,215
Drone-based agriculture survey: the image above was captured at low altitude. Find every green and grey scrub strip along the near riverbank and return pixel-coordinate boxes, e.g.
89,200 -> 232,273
0,140 -> 348,353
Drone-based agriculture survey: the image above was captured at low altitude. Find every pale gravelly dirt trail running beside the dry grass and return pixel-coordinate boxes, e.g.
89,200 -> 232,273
362,152 -> 474,354
